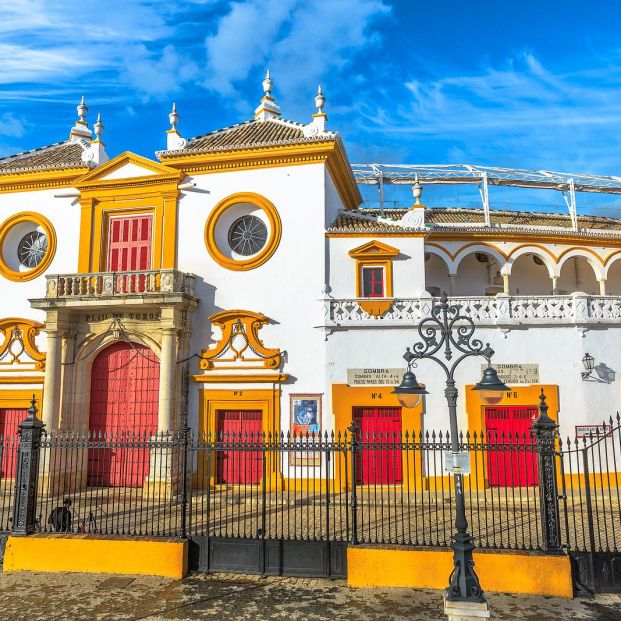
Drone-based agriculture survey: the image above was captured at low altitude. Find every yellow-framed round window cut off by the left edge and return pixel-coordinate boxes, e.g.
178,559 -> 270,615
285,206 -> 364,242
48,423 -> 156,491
0,212 -> 56,282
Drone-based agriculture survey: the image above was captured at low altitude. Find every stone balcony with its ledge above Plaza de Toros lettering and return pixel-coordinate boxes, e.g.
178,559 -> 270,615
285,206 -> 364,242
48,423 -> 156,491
31,269 -> 195,309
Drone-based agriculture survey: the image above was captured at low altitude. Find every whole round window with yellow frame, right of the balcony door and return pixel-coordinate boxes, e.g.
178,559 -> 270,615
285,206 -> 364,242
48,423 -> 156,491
205,192 -> 282,271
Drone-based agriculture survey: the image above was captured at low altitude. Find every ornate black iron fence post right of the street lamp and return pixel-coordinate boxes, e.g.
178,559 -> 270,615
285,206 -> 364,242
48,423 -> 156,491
532,389 -> 562,553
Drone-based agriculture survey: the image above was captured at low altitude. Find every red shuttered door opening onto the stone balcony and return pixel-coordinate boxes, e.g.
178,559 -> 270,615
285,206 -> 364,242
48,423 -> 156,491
107,215 -> 152,293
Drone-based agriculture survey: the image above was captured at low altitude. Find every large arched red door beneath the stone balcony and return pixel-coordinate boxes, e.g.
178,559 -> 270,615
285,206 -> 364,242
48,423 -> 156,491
88,342 -> 160,487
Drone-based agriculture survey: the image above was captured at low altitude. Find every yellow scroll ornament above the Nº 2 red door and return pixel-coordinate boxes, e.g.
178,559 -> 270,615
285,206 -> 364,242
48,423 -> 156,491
200,310 -> 282,370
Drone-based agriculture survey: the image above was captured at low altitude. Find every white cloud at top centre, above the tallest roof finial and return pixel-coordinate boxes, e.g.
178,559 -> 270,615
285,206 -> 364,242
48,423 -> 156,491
205,0 -> 389,103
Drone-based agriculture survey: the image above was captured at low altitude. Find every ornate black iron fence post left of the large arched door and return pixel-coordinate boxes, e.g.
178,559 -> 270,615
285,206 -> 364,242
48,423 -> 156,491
11,395 -> 45,536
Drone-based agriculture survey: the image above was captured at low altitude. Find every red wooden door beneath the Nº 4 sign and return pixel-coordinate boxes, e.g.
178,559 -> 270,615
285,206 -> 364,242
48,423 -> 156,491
353,407 -> 402,485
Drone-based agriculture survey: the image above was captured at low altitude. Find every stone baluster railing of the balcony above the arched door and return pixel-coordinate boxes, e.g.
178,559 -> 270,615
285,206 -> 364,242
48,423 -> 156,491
46,269 -> 194,299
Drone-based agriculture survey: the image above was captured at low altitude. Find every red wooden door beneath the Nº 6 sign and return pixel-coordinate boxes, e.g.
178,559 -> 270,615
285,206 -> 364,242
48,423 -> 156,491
485,405 -> 538,487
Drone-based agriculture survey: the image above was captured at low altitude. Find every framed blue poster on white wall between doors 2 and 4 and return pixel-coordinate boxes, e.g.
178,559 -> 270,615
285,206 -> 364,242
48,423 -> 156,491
290,395 -> 321,466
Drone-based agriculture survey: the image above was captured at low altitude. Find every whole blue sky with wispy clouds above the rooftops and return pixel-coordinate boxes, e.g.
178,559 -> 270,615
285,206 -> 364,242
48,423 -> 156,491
0,0 -> 621,183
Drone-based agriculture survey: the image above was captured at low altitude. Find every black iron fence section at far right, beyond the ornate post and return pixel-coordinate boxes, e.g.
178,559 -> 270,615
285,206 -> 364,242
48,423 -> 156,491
558,413 -> 621,552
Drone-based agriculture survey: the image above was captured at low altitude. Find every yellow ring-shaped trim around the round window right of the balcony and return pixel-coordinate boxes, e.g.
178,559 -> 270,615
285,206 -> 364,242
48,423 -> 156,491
205,192 -> 282,272
